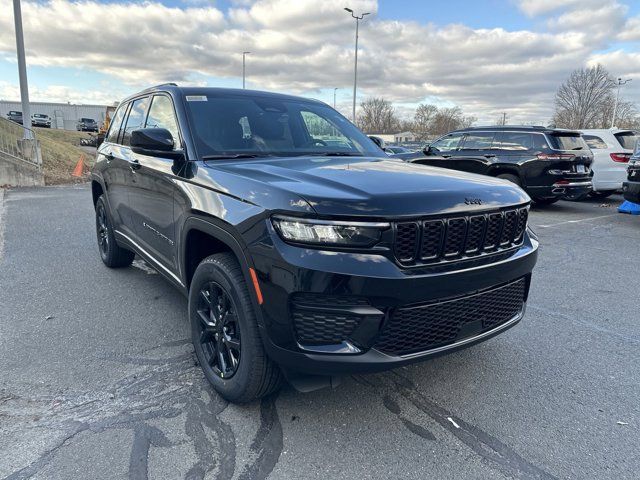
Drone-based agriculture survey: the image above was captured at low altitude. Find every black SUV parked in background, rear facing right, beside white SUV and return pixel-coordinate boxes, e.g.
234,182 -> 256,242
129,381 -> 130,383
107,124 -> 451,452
409,126 -> 593,204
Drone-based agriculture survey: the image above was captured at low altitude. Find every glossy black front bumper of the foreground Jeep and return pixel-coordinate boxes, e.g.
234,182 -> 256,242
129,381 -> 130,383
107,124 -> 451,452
250,229 -> 538,375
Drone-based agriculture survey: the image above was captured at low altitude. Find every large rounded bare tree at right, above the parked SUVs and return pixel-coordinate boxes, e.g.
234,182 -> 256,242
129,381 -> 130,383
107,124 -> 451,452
553,65 -> 615,129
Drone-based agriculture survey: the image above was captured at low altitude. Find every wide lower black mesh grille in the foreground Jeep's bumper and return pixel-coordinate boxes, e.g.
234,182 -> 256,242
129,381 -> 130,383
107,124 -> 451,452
374,278 -> 526,355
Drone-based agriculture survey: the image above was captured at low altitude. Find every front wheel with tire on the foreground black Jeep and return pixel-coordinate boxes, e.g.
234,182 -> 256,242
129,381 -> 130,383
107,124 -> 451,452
189,253 -> 283,403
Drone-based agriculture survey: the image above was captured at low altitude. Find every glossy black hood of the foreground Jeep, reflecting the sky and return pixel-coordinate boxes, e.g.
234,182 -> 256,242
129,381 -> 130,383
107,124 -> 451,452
209,157 -> 530,217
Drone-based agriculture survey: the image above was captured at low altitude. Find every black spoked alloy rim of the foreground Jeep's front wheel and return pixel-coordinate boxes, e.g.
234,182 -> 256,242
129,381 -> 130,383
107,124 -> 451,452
197,282 -> 241,379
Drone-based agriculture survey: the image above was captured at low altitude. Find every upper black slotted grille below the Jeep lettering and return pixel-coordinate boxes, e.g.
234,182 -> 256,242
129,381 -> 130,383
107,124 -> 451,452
394,207 -> 529,266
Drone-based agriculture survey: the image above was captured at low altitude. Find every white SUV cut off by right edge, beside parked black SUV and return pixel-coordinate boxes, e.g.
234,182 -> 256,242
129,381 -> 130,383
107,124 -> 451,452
580,128 -> 640,198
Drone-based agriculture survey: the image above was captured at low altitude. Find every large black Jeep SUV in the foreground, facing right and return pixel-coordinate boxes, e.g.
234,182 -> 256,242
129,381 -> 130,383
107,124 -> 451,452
92,85 -> 538,402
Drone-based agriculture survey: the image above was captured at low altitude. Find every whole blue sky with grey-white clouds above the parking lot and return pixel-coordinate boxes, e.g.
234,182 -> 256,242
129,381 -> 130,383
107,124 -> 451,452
0,0 -> 640,123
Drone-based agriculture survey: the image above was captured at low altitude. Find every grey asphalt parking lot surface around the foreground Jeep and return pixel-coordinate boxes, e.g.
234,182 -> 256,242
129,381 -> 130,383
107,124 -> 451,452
0,185 -> 640,479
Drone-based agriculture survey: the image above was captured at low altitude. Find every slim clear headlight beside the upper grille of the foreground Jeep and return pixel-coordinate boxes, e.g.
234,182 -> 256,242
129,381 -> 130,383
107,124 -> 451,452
271,216 -> 389,247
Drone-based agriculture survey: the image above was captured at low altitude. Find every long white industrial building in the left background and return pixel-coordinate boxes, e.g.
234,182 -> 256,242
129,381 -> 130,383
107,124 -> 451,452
0,100 -> 114,130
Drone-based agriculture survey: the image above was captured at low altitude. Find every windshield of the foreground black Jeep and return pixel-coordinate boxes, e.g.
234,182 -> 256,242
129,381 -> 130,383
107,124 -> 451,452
185,92 -> 385,158
